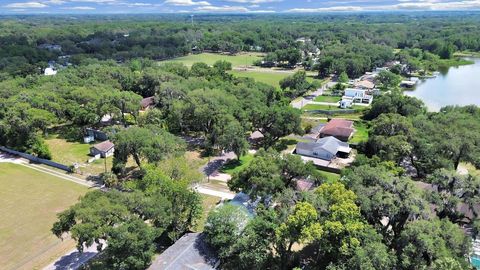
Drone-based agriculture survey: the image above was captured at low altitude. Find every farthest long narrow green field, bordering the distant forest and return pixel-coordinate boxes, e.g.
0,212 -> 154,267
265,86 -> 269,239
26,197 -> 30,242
160,53 -> 263,67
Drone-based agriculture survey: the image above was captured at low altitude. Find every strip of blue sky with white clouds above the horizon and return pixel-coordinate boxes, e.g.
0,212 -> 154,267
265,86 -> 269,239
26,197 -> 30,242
0,0 -> 480,14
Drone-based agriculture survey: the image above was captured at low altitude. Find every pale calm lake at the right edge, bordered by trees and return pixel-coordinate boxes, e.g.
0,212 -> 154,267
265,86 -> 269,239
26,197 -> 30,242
405,58 -> 480,111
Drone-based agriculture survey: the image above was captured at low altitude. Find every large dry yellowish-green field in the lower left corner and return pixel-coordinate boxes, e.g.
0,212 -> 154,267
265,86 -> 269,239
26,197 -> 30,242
0,163 -> 87,269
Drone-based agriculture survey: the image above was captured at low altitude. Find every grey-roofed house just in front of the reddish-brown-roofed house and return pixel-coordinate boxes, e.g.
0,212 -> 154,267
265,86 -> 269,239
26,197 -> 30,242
295,136 -> 352,161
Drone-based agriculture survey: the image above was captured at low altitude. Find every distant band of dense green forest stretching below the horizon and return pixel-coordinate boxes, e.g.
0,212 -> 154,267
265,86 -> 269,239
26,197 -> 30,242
0,12 -> 480,76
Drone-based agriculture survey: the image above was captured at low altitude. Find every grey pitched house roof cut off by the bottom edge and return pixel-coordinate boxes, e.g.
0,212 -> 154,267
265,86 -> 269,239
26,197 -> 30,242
148,233 -> 220,270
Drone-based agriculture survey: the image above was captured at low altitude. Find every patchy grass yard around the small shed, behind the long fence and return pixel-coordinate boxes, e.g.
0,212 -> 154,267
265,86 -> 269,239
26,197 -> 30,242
45,135 -> 113,176
